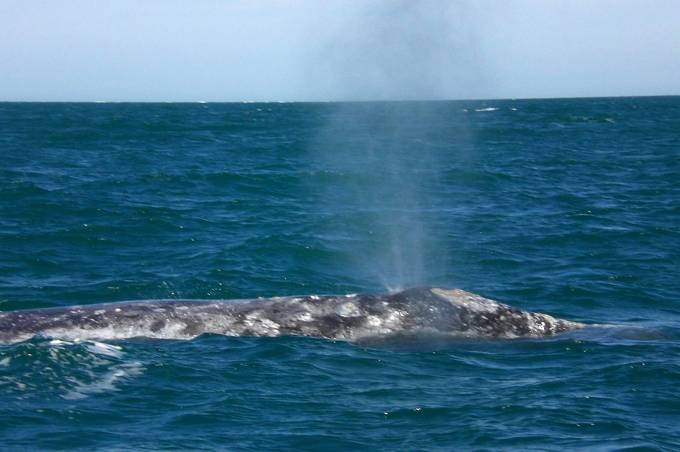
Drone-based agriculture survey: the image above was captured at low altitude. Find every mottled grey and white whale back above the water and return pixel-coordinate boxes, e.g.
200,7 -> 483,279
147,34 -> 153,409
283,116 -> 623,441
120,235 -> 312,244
0,288 -> 584,343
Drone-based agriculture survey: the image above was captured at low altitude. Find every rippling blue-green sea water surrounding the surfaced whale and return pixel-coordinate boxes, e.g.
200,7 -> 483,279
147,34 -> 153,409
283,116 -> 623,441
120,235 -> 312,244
0,97 -> 680,450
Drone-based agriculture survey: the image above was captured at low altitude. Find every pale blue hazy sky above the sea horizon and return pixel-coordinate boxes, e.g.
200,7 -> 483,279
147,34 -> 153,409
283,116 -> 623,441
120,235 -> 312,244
0,0 -> 680,101
